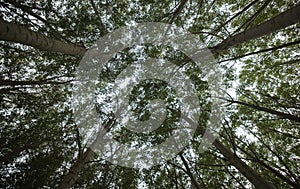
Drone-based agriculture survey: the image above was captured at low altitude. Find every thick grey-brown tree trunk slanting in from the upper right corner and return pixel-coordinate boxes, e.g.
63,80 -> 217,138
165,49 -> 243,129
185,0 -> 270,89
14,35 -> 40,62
210,4 -> 300,54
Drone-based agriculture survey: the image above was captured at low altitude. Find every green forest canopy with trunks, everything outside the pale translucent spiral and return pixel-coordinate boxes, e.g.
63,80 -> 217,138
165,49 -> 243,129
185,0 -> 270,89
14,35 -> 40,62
0,0 -> 300,189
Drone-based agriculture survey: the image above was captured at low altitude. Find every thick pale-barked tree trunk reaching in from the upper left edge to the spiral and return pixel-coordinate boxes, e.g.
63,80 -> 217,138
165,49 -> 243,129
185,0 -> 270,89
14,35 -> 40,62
0,18 -> 86,56
